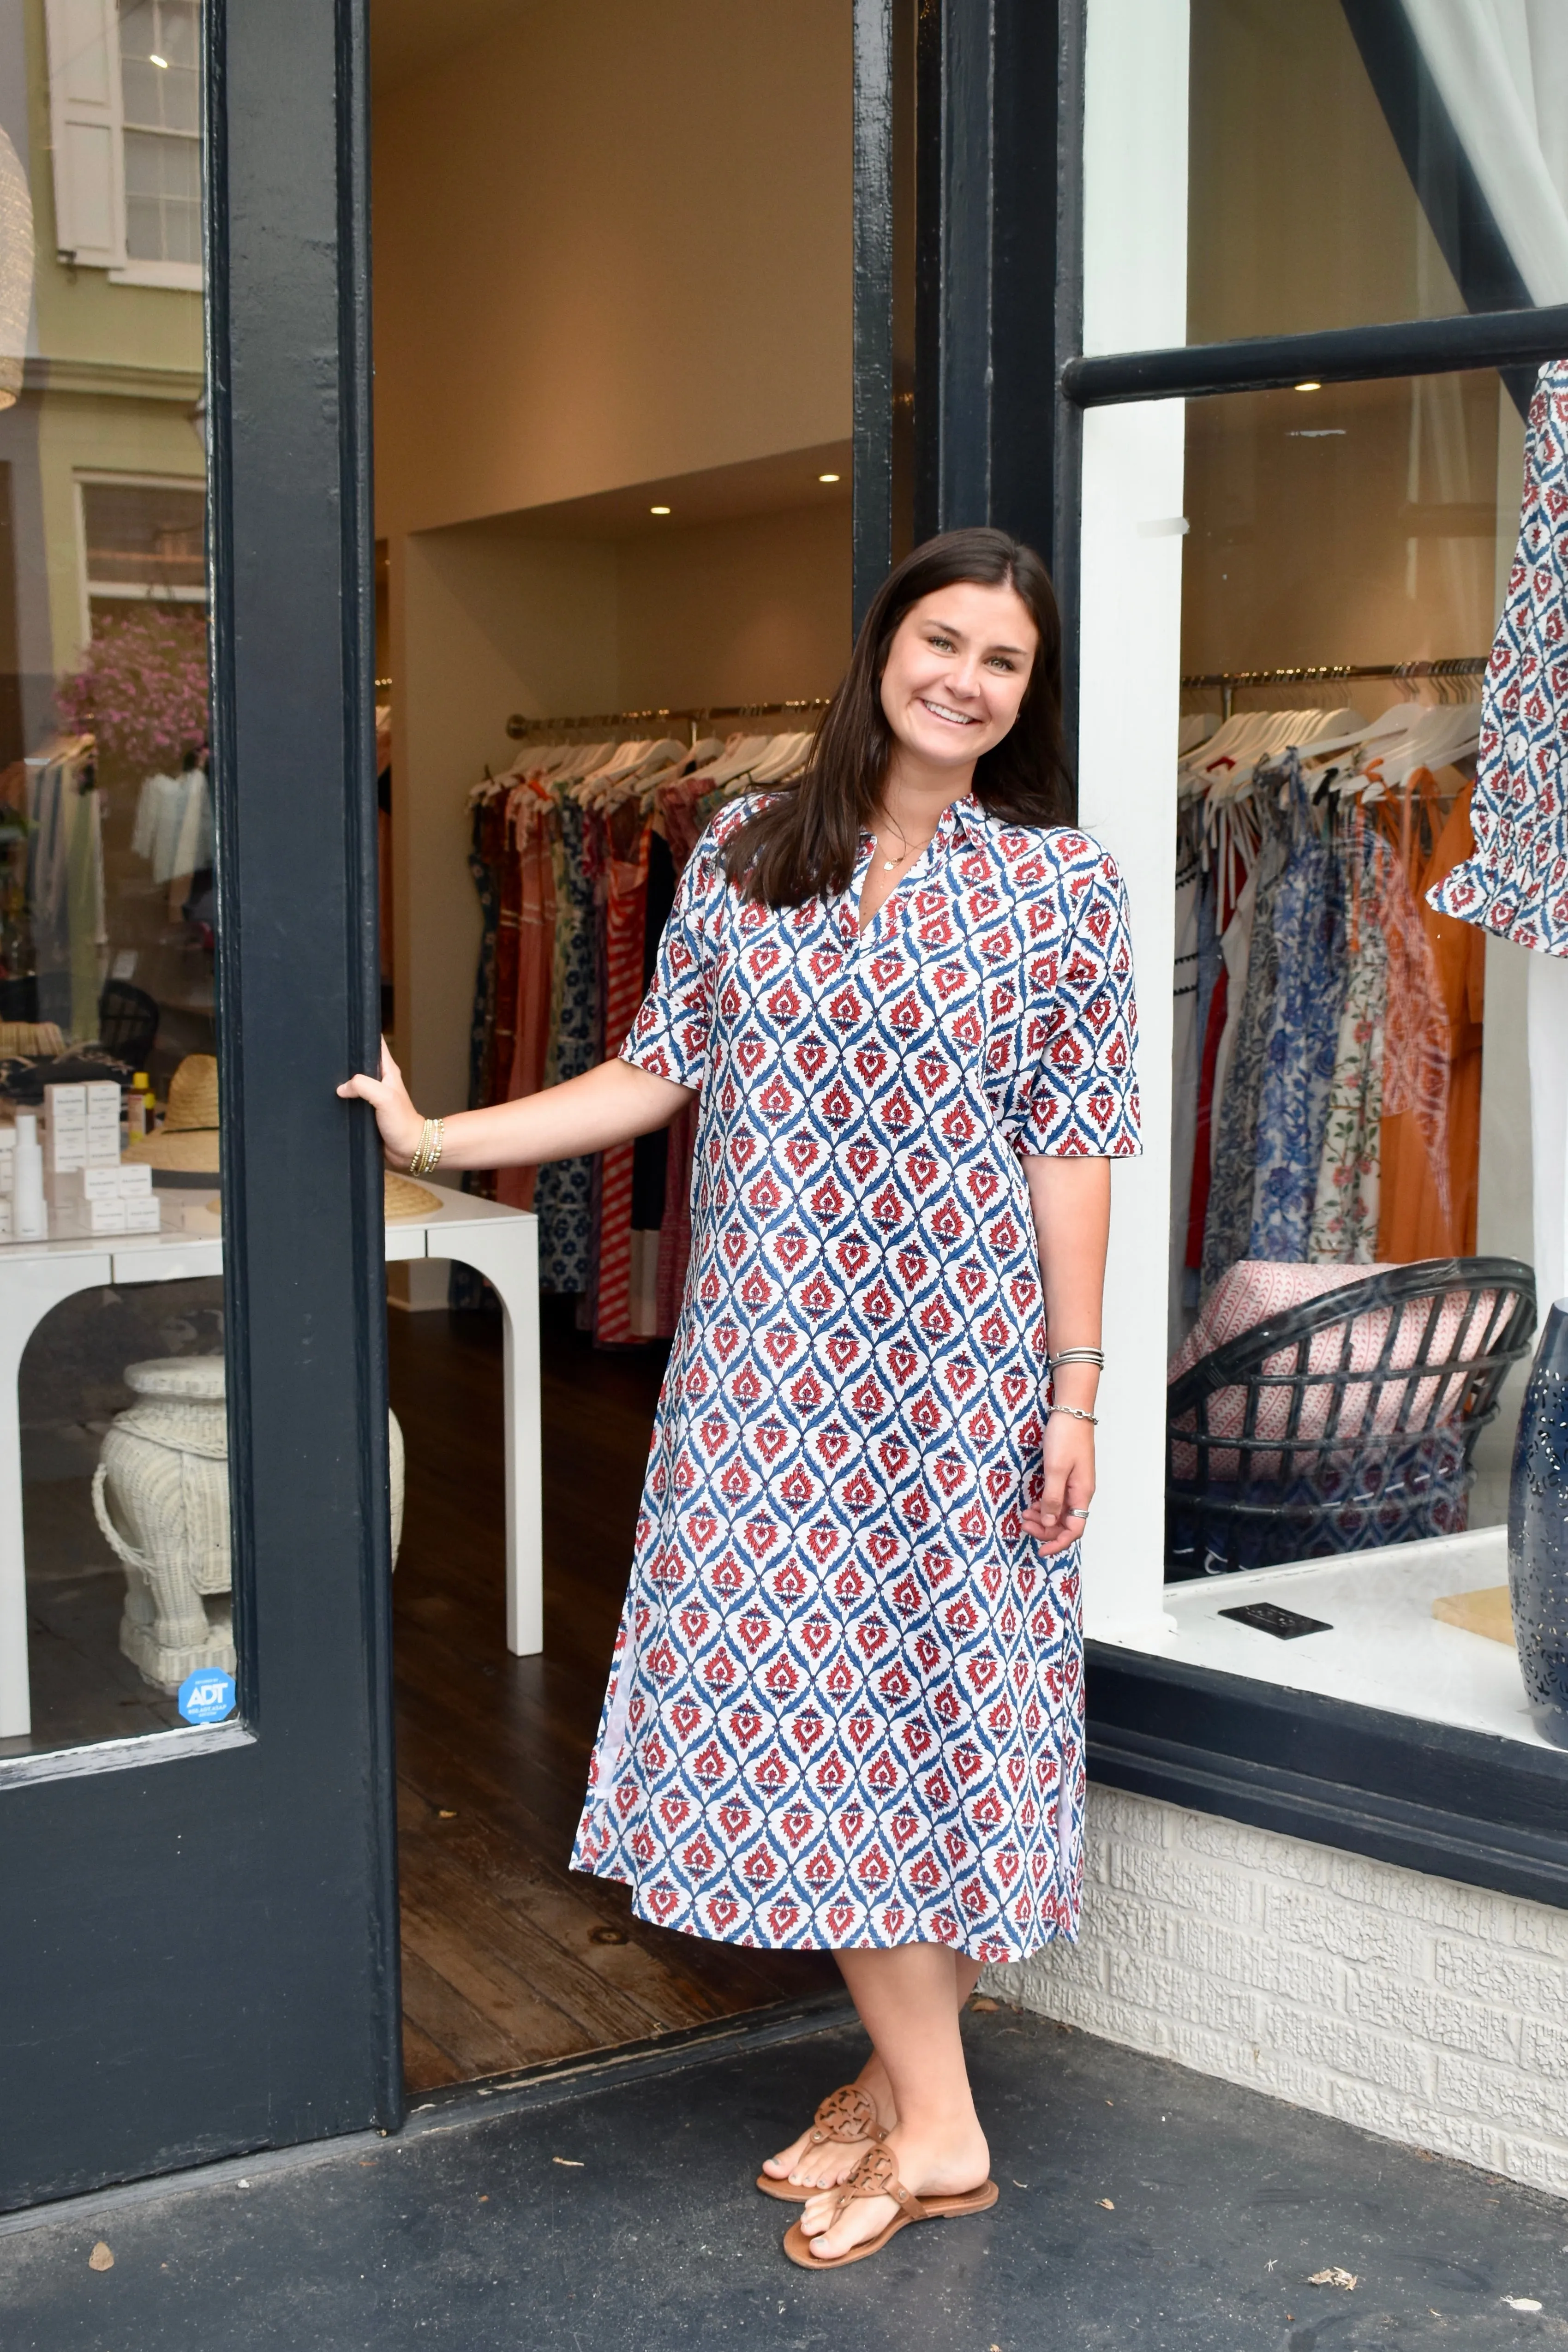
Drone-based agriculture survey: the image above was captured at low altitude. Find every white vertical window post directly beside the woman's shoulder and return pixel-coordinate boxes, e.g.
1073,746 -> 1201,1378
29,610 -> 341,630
1079,0 -> 1190,1649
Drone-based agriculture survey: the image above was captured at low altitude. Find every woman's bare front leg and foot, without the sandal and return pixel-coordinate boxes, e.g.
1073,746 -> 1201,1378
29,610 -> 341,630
802,1943 -> 990,2256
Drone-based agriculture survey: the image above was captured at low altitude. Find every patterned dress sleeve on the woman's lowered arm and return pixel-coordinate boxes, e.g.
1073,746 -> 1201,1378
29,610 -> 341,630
1018,835 -> 1143,1160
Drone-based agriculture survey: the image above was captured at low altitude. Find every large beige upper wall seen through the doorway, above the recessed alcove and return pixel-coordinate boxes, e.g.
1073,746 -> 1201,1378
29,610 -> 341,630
374,0 -> 851,536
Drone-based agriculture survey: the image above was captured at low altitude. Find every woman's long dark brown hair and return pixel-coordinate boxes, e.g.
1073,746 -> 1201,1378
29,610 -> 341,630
724,527 -> 1072,905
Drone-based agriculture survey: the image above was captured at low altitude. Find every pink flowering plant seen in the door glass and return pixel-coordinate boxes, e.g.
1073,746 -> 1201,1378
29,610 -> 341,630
54,604 -> 207,776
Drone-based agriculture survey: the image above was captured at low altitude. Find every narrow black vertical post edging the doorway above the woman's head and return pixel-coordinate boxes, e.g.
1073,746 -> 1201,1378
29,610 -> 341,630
853,0 -> 893,628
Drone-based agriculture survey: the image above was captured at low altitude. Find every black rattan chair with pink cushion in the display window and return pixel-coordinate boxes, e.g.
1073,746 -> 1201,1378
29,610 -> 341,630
1166,1258 -> 1535,1578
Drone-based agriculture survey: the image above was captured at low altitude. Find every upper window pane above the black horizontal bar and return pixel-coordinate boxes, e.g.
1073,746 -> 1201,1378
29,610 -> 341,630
1187,0 -> 1568,343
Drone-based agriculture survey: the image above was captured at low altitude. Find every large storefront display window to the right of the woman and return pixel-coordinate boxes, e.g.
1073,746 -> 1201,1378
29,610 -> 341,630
1079,0 -> 1568,1741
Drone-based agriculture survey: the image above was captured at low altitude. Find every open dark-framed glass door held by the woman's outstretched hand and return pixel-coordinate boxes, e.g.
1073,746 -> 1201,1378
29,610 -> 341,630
0,0 -> 402,2206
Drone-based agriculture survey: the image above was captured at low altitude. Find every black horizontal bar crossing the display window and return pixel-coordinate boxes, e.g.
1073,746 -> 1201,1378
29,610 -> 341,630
1060,304 -> 1568,409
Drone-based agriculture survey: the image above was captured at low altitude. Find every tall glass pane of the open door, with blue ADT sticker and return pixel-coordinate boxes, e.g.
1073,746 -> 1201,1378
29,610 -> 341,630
0,0 -> 235,1754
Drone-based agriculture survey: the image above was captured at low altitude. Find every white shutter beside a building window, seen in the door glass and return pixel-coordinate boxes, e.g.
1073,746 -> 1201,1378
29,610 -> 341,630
45,0 -> 125,270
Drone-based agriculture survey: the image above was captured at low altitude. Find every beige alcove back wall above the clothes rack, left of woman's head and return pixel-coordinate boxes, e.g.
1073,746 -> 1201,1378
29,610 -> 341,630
614,499 -> 851,710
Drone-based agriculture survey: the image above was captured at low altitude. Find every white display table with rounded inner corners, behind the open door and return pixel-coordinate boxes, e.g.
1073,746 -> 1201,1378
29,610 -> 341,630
0,1192 -> 545,1738
